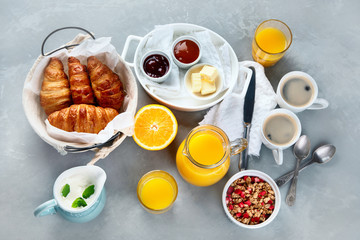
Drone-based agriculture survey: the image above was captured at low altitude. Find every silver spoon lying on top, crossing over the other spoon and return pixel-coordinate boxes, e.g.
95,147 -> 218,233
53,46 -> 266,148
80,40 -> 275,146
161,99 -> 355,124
285,135 -> 311,206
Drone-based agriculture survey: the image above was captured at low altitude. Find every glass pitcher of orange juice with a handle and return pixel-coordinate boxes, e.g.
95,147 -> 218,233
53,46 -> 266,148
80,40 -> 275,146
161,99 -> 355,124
176,125 -> 247,187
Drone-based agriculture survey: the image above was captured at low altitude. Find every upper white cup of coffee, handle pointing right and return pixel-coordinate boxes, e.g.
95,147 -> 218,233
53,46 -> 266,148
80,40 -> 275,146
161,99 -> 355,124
276,71 -> 329,113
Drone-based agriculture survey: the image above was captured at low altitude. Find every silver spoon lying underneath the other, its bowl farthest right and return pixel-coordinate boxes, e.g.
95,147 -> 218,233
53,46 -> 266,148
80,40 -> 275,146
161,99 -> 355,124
275,144 -> 336,187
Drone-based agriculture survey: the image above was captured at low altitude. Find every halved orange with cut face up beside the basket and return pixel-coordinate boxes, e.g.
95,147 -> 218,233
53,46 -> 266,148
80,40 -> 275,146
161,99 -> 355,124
133,104 -> 178,151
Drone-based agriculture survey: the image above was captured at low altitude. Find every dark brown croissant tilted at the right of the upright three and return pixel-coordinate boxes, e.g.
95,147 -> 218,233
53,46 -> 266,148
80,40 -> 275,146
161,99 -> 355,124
87,56 -> 125,111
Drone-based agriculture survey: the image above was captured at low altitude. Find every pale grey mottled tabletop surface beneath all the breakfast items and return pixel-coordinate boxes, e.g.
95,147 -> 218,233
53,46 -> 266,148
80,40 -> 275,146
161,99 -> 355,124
0,0 -> 360,240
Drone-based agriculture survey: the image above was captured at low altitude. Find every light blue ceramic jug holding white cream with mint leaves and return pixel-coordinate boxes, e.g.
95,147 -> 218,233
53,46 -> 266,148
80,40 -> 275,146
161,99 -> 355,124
34,166 -> 106,223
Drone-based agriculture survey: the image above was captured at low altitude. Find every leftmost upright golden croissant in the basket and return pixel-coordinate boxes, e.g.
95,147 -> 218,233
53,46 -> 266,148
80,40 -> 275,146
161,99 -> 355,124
40,58 -> 71,115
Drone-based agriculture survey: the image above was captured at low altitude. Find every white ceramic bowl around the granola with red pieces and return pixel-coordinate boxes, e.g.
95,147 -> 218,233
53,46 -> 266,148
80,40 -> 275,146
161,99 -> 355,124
222,170 -> 281,229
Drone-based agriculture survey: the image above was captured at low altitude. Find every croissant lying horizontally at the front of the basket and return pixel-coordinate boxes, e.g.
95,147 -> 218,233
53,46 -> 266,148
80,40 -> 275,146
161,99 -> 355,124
48,104 -> 118,133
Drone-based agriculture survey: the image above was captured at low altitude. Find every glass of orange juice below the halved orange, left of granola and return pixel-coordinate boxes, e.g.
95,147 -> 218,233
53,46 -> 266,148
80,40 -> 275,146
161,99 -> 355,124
137,170 -> 178,214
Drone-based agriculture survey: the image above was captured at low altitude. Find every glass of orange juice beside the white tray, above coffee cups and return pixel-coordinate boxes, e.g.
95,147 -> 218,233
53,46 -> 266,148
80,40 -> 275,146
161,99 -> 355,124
252,19 -> 292,67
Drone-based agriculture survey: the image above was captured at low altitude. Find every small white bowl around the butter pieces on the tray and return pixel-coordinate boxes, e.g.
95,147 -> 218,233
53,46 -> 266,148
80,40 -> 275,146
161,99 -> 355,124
184,63 -> 224,100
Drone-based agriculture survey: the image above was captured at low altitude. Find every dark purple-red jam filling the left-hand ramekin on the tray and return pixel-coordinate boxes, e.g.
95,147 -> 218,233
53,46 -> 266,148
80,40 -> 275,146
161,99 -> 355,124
143,54 -> 170,78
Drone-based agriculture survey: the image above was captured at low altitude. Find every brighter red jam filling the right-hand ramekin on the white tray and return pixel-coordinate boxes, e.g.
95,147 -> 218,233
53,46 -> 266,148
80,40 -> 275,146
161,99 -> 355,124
174,39 -> 200,64
